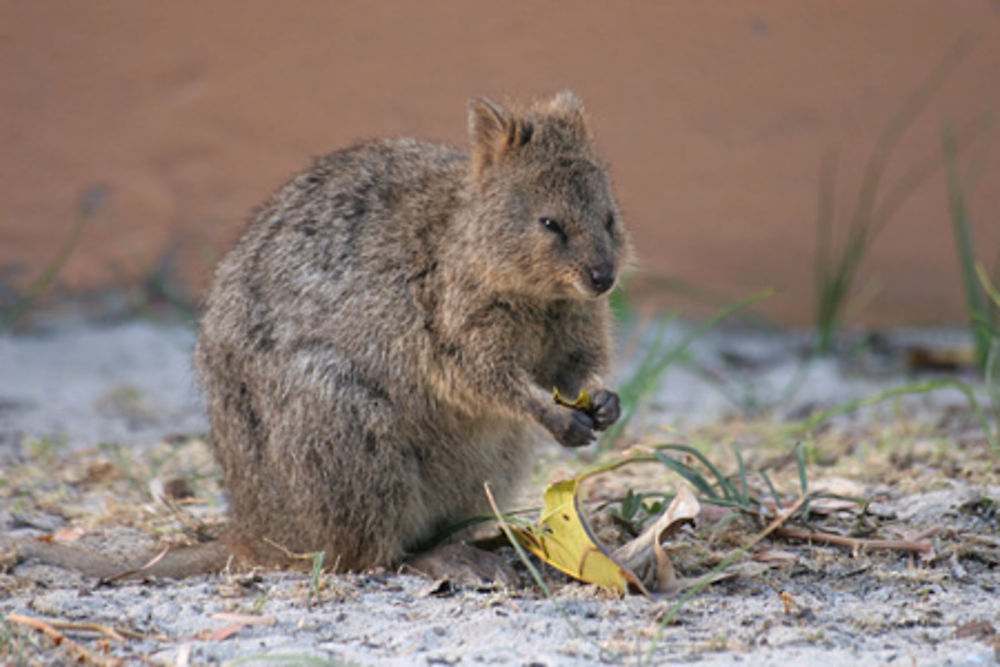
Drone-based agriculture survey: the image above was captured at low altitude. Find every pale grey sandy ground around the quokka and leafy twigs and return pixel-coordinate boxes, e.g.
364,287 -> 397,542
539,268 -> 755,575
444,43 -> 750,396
0,321 -> 1000,665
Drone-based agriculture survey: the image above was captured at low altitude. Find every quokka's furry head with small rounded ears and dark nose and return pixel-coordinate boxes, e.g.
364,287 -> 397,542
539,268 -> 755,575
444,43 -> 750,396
468,91 -> 630,299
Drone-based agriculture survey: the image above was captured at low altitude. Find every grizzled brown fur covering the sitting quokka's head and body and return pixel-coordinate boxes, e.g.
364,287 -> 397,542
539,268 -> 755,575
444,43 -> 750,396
7,92 -> 628,576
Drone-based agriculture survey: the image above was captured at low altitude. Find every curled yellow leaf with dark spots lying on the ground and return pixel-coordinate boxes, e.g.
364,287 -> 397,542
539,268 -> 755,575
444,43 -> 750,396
515,472 -> 646,595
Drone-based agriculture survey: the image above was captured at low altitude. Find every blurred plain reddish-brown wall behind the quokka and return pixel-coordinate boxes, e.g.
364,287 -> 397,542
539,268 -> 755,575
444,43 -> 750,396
0,0 -> 1000,324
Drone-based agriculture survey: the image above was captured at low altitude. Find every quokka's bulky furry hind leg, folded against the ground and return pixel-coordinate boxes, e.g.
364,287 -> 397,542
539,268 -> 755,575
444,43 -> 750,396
215,378 -> 435,570
